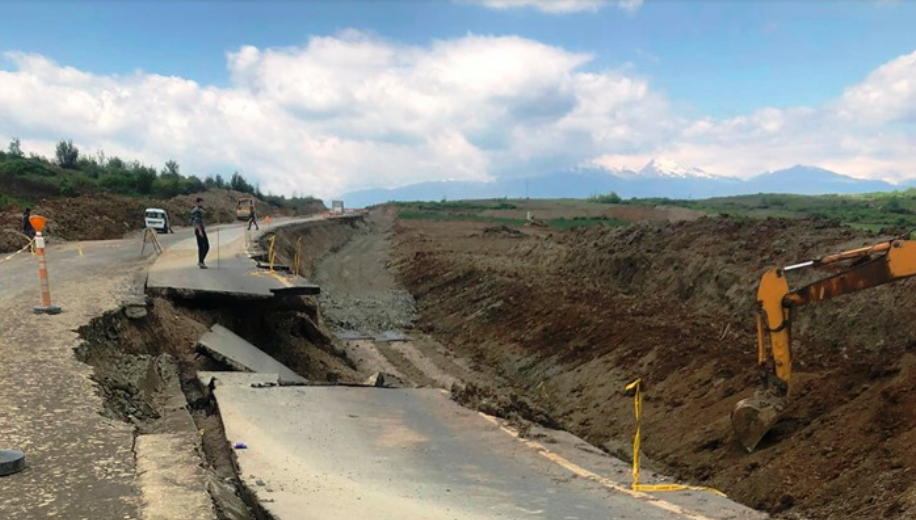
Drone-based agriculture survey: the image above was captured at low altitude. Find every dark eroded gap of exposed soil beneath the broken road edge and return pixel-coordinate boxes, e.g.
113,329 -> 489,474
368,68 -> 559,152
75,296 -> 359,520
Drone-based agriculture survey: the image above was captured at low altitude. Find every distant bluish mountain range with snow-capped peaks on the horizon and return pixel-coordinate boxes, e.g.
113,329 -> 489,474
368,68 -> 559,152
343,159 -> 907,207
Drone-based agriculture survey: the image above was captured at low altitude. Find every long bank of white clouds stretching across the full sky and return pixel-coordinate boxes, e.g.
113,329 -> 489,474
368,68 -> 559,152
0,31 -> 916,198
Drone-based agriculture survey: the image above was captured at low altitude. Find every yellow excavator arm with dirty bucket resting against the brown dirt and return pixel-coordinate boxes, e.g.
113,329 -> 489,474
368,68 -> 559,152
731,239 -> 916,452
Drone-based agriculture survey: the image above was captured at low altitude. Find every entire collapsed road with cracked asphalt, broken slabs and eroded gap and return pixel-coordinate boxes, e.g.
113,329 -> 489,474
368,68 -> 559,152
0,210 -> 765,519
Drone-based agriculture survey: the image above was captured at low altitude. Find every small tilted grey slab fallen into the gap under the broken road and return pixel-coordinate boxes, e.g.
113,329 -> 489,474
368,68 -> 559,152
198,324 -> 308,383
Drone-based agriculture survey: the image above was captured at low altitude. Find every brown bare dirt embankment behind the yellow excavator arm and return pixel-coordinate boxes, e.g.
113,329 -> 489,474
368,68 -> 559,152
393,212 -> 916,519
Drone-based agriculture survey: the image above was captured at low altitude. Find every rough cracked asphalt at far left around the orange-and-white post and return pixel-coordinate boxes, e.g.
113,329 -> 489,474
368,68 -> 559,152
0,235 -> 181,520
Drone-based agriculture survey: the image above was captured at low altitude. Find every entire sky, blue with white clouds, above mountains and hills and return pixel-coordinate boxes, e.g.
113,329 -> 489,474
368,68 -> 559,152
0,0 -> 916,198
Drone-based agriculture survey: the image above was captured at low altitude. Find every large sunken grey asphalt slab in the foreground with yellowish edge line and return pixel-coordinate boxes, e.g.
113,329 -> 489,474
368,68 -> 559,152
213,373 -> 763,520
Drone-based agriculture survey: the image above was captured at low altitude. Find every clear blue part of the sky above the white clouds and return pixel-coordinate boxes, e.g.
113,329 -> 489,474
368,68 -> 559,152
0,0 -> 916,195
